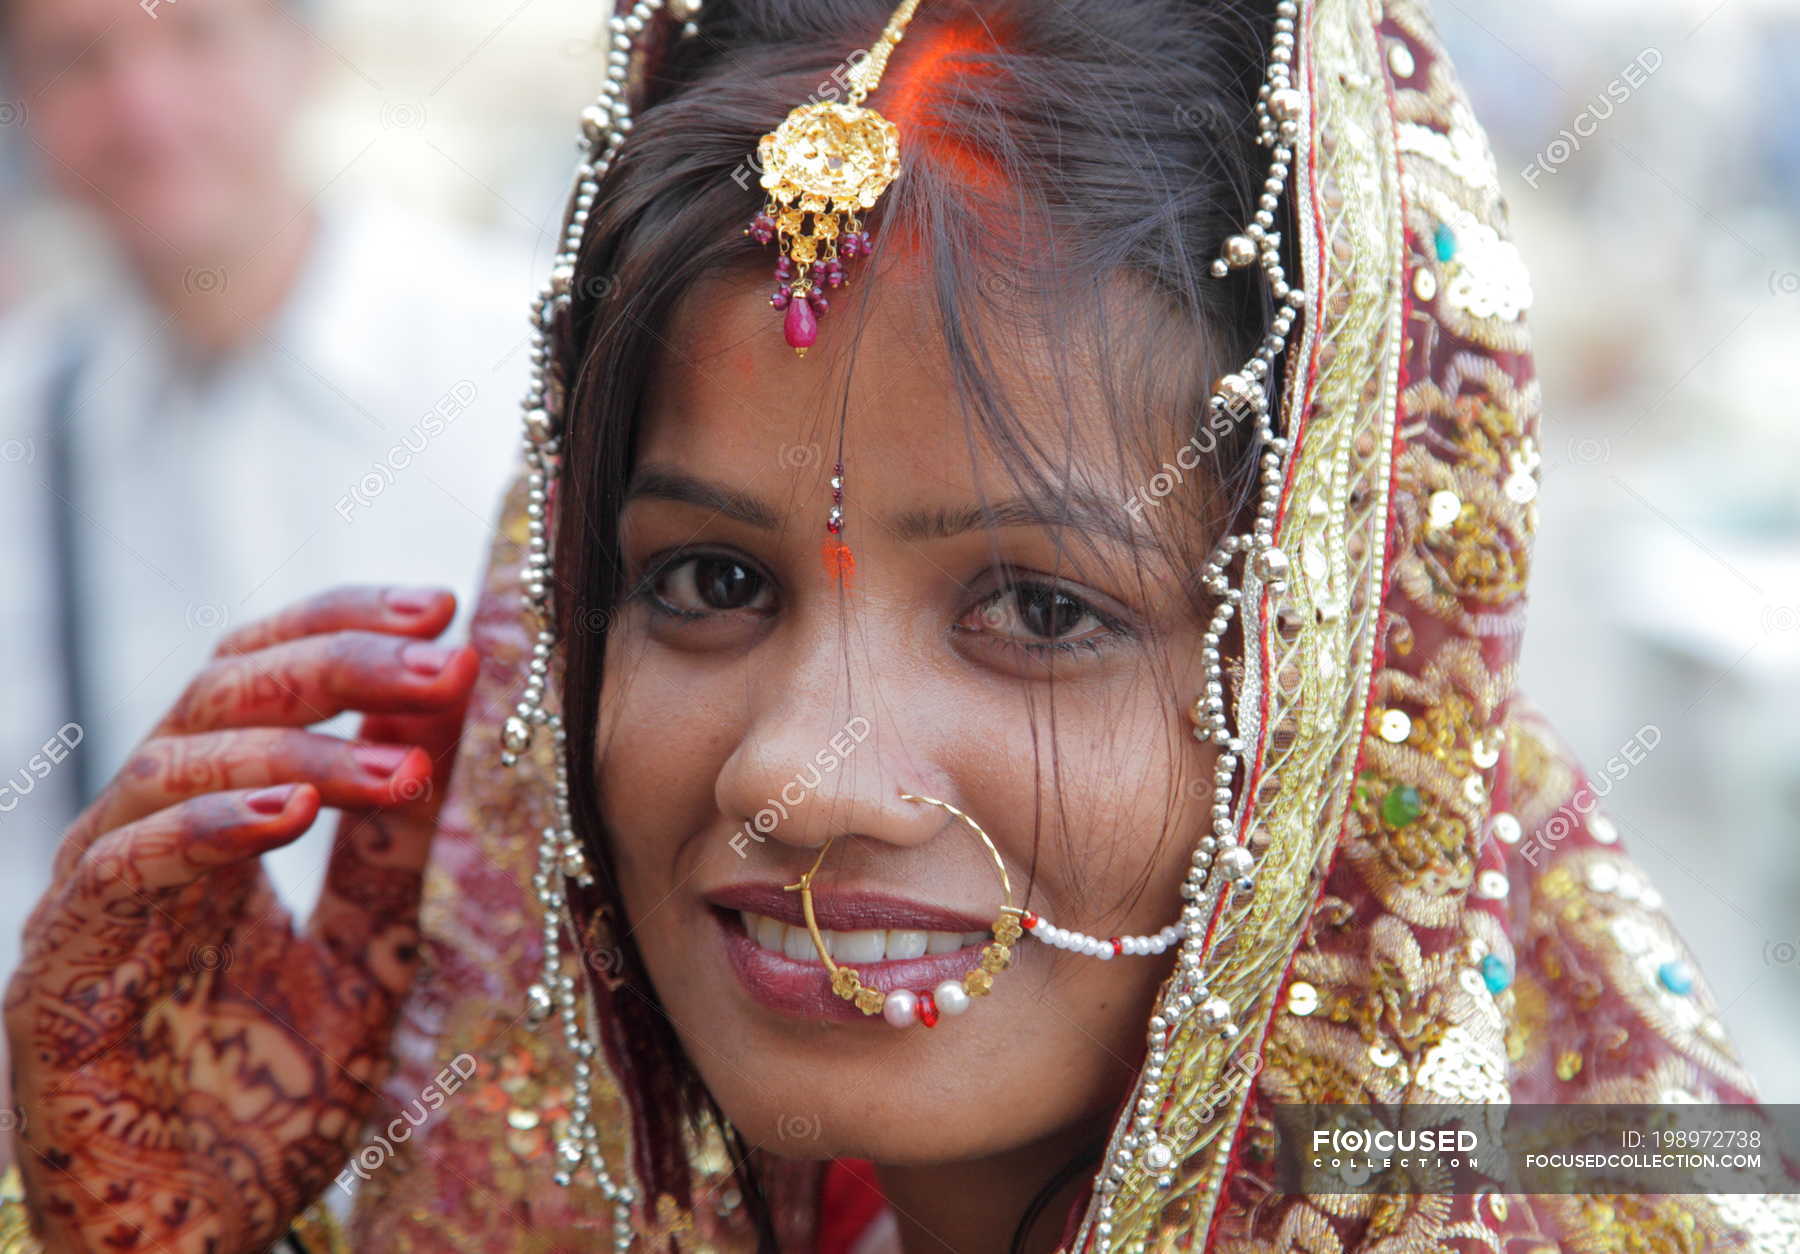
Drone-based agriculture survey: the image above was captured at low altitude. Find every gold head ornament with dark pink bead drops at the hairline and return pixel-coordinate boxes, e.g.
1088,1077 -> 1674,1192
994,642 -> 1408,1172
743,0 -> 918,356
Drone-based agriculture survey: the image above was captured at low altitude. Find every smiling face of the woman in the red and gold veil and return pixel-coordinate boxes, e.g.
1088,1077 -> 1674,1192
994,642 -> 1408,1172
596,264 -> 1213,1164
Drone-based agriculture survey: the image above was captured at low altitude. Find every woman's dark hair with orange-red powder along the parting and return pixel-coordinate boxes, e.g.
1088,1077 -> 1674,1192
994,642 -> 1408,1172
553,0 -> 1273,1249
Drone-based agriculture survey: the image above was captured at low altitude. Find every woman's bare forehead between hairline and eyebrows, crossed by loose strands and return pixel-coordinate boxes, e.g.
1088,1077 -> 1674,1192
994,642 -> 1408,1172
639,264 -> 1190,498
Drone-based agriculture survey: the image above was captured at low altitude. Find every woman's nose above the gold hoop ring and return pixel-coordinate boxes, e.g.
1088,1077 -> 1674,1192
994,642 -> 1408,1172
715,624 -> 950,855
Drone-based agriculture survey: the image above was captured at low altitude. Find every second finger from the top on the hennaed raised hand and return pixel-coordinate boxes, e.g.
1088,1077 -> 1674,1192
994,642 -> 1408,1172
153,631 -> 479,736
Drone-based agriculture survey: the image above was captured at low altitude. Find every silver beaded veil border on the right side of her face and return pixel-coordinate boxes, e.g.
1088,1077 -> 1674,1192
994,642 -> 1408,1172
1076,0 -> 1307,1249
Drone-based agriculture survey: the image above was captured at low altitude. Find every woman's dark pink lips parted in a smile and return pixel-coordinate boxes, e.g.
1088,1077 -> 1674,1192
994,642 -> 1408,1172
706,885 -> 992,1031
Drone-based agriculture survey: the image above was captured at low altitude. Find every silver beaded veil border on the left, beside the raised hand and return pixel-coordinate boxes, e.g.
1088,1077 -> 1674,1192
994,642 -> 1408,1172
500,0 -> 700,1254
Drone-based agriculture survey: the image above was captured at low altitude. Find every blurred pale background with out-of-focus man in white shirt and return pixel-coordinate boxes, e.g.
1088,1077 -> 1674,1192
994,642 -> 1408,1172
0,0 -> 1800,1101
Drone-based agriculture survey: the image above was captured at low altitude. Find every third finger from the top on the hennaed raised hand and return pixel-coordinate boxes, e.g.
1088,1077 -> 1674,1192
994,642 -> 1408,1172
59,727 -> 432,860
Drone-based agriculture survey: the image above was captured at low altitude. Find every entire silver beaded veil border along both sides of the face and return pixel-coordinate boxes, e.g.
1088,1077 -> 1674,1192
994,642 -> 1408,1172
500,0 -> 1307,1254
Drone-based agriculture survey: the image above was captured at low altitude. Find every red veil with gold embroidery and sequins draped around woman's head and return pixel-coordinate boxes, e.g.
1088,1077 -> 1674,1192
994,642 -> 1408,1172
340,0 -> 1800,1254
